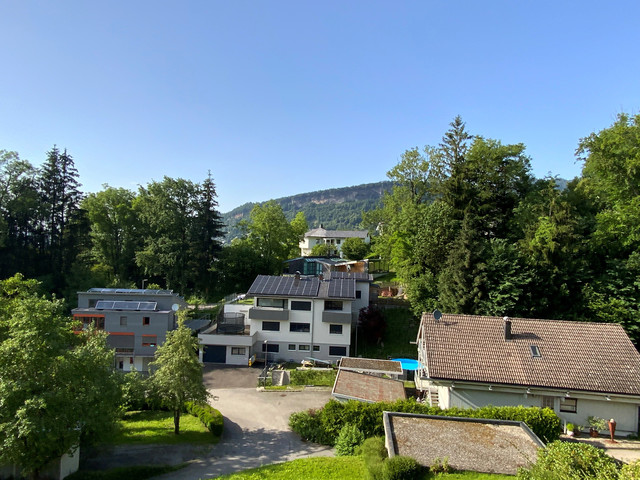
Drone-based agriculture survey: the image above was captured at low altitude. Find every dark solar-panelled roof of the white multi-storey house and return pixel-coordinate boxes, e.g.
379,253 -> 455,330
247,275 -> 356,299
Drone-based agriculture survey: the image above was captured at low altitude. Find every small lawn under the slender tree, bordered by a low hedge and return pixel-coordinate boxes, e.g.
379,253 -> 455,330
111,410 -> 217,445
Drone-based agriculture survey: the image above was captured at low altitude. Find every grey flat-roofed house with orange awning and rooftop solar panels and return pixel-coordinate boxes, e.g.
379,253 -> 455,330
72,288 -> 187,372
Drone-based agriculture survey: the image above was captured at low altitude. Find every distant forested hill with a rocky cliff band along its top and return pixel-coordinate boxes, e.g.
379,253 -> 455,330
222,181 -> 392,241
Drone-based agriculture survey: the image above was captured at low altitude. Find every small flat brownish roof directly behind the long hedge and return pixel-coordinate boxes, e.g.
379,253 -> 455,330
331,369 -> 407,402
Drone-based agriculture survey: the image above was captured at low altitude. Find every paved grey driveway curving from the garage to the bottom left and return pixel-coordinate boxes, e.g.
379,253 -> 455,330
84,366 -> 333,480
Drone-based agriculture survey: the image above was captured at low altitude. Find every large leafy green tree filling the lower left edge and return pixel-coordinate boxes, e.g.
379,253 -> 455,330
0,275 -> 120,478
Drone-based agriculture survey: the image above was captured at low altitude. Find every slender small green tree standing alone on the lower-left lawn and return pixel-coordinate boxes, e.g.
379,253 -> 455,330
149,311 -> 208,435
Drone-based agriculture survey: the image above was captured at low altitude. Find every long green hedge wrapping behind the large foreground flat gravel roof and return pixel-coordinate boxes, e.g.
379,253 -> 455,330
289,399 -> 562,445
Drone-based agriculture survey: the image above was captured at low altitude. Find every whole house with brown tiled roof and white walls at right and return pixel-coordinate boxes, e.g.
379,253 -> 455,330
416,312 -> 640,435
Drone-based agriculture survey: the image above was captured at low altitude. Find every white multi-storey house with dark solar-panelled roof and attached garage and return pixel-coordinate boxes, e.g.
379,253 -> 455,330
198,272 -> 371,365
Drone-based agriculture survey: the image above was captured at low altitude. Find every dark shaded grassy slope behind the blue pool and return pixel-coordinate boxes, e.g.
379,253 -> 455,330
358,308 -> 420,360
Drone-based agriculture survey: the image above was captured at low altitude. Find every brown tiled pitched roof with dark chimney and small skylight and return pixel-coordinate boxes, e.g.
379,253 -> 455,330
419,314 -> 640,395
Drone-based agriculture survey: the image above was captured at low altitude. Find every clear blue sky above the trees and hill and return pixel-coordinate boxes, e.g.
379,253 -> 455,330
0,0 -> 640,212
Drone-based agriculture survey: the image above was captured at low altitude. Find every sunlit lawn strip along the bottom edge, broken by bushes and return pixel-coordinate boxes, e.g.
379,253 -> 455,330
210,457 -> 515,480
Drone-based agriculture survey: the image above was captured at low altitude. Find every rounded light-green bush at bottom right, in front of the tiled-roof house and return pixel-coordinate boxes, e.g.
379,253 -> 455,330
518,441 -> 620,480
